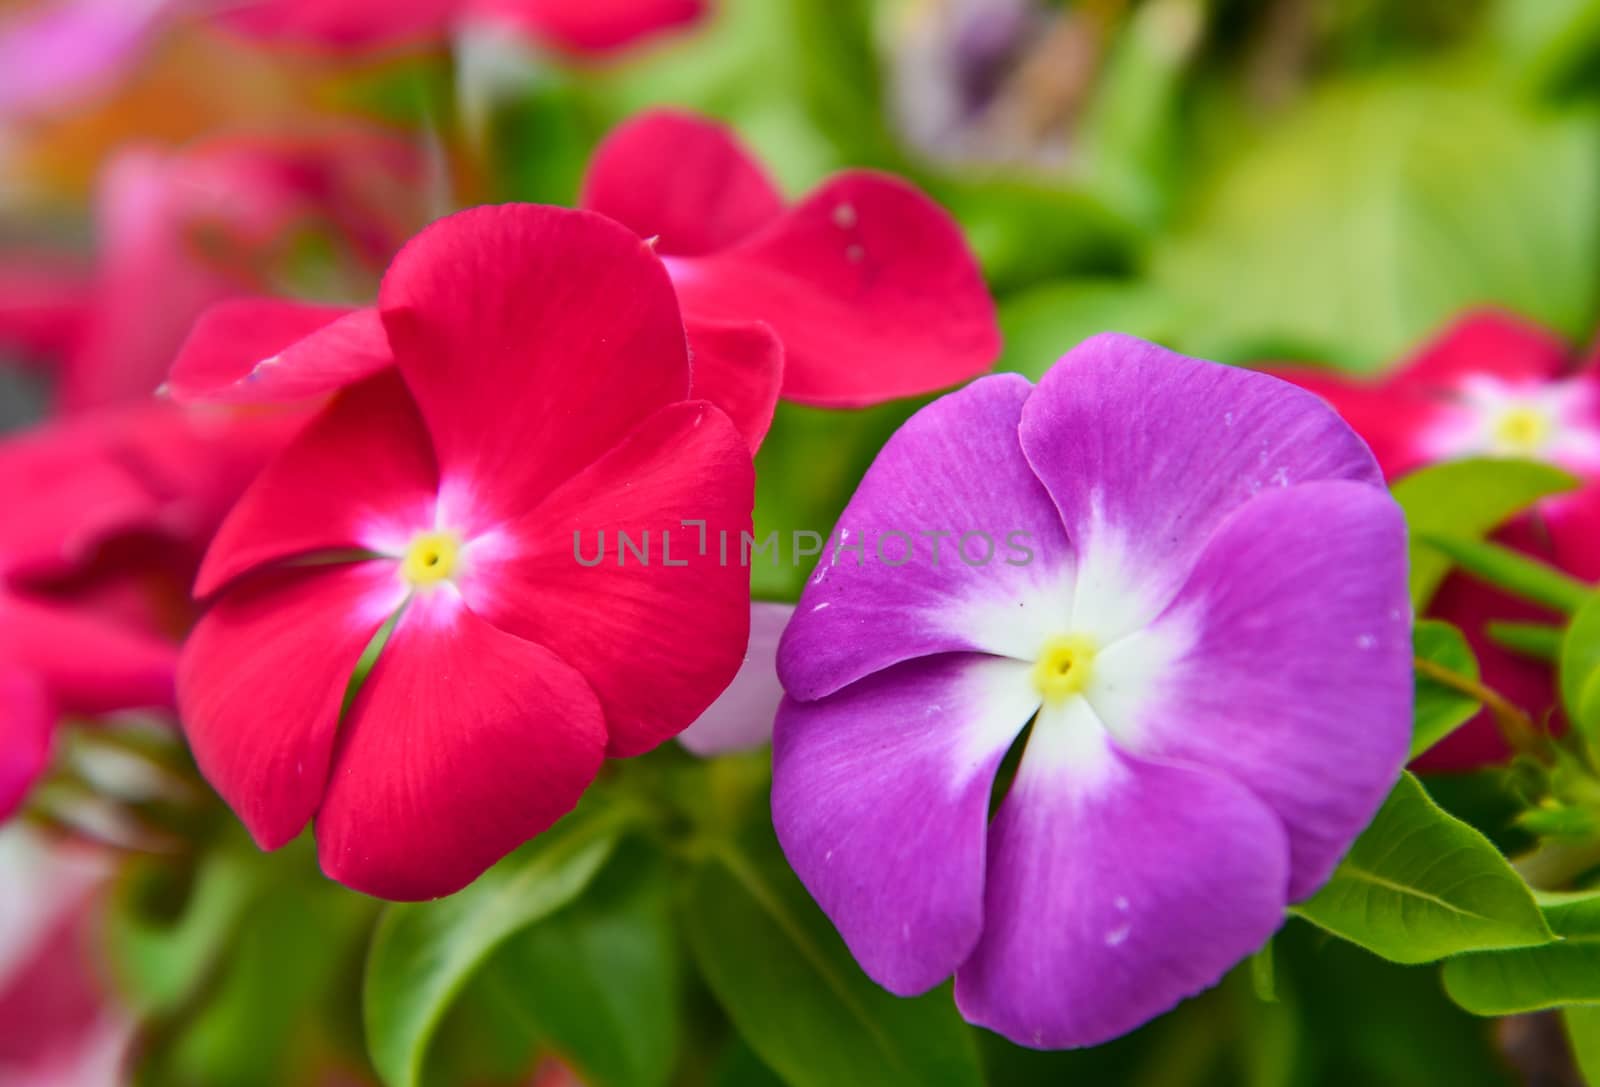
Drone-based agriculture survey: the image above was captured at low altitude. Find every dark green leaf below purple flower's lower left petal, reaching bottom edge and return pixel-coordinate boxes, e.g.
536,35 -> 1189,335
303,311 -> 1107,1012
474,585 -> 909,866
683,842 -> 982,1087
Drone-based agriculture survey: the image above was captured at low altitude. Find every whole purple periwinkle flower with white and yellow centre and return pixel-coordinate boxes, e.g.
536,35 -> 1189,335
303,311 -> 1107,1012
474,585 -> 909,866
773,335 -> 1411,1049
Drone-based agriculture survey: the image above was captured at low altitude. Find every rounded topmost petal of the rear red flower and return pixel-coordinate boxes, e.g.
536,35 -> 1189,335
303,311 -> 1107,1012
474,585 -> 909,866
579,109 -> 784,256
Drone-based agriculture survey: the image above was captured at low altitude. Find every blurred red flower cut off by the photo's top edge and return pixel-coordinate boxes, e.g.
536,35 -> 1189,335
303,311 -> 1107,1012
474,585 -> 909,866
221,0 -> 706,53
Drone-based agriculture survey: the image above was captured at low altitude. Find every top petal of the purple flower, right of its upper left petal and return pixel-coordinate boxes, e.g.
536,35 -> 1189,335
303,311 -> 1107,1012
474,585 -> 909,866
1021,333 -> 1382,634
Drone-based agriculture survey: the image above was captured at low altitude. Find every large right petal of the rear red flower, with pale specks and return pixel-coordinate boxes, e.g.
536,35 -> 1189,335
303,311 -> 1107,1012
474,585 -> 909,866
672,173 -> 1000,407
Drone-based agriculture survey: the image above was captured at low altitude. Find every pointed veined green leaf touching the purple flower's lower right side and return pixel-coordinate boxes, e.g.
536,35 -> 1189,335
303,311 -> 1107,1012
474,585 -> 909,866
1294,773 -> 1550,964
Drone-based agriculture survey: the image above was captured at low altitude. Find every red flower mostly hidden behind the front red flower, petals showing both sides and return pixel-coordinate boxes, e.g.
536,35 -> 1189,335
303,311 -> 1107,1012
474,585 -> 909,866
168,112 -> 1000,448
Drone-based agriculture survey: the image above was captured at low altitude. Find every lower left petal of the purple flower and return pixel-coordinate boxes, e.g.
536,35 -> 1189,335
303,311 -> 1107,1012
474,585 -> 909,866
773,653 -> 1038,996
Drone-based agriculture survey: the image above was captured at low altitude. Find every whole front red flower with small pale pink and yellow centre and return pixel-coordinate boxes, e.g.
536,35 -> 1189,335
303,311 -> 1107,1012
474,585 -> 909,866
178,205 -> 754,898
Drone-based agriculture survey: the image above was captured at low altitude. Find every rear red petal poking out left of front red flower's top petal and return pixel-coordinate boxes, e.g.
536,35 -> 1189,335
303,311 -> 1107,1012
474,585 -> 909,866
166,298 -> 394,403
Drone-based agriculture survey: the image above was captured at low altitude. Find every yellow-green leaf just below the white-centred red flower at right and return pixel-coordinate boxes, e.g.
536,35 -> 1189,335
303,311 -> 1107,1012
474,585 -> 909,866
1394,459 -> 1578,610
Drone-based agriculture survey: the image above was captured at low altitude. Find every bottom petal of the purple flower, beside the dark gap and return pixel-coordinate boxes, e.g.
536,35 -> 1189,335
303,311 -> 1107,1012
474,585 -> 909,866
955,717 -> 1288,1049
